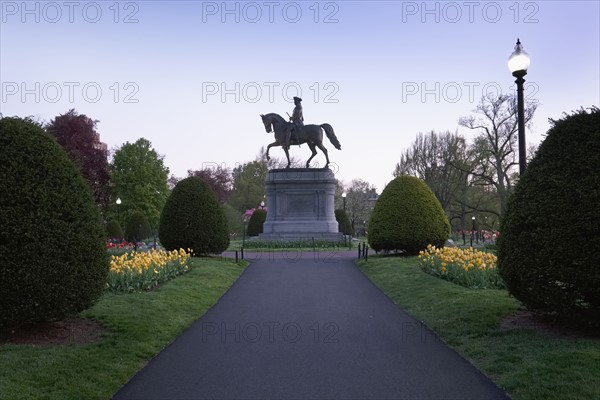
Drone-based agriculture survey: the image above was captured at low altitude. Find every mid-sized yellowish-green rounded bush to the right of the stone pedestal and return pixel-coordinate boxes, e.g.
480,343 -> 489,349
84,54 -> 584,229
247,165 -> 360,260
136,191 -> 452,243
368,176 -> 450,255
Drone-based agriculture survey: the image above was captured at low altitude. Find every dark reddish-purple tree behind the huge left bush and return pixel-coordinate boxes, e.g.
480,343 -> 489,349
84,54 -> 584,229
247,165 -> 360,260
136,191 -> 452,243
46,109 -> 110,207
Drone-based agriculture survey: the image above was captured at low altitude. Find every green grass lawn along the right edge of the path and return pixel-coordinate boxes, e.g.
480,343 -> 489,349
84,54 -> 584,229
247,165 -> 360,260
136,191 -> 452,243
359,257 -> 600,400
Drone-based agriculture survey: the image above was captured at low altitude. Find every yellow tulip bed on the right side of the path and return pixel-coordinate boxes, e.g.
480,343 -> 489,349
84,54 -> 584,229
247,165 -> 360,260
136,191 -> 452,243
418,245 -> 506,289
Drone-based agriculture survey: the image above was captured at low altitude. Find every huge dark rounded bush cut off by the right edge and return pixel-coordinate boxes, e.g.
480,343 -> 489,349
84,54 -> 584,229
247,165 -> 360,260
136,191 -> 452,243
498,108 -> 600,326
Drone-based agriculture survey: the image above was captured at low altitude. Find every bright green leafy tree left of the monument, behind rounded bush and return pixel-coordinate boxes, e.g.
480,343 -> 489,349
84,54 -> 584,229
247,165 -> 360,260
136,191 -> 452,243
110,138 -> 169,227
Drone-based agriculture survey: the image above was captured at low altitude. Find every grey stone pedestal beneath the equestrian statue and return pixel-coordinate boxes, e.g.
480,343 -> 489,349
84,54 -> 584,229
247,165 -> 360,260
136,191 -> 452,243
259,168 -> 341,241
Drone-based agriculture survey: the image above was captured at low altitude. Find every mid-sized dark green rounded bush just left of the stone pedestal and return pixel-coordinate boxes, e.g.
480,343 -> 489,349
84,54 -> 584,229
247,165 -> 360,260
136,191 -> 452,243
158,176 -> 229,255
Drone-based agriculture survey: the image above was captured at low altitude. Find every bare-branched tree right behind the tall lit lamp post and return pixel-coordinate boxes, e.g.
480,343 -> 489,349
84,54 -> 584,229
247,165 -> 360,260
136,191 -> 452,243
458,94 -> 537,214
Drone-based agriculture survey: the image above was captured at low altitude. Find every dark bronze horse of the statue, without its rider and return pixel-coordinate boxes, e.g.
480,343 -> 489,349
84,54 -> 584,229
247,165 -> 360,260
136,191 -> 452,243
260,113 -> 342,168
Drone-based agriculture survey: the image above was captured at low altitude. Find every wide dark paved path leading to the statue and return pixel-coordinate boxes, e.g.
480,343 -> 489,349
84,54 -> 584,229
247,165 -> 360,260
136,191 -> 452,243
114,251 -> 508,400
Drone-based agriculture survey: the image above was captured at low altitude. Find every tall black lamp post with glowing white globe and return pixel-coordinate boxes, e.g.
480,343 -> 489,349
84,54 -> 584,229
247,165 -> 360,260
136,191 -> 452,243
508,39 -> 531,175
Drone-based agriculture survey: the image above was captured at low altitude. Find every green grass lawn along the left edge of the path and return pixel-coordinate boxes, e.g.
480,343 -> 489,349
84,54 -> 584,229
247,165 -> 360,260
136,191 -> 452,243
0,258 -> 244,400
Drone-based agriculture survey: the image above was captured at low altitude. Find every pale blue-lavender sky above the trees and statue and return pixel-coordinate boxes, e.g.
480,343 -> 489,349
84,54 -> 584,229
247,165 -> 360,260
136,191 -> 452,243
0,1 -> 600,191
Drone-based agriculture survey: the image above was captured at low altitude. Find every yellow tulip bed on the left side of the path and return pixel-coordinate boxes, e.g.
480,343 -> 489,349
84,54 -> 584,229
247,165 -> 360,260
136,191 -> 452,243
106,249 -> 192,293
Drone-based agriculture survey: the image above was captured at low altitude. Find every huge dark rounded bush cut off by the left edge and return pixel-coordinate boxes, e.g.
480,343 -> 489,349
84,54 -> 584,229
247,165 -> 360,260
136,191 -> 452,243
0,118 -> 109,329
